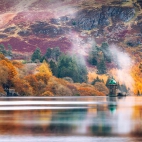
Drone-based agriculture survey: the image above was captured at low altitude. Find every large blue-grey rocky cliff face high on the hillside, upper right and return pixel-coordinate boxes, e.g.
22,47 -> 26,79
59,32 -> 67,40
75,6 -> 136,30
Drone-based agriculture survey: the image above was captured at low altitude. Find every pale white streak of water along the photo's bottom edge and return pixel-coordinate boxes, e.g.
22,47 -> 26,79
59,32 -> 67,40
0,136 -> 142,142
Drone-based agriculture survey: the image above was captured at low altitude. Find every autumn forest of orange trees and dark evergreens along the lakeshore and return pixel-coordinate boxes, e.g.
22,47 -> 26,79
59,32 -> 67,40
0,42 -> 142,96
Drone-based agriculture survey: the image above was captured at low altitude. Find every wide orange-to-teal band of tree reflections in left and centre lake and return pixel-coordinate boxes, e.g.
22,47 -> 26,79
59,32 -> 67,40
0,109 -> 87,135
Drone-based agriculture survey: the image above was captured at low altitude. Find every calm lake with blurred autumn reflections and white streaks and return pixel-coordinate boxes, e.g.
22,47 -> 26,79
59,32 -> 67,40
0,97 -> 142,142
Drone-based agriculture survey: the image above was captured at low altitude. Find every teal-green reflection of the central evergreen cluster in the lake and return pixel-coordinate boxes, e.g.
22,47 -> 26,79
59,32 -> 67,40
50,109 -> 87,133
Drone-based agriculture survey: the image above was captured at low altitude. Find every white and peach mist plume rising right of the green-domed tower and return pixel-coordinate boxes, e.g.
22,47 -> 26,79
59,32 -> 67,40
110,44 -> 134,91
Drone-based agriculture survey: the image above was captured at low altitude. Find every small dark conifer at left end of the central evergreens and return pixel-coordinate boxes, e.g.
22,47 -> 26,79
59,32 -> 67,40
31,48 -> 42,62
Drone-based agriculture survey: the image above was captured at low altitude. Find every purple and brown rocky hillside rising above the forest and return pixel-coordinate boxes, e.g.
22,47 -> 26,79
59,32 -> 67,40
0,0 -> 142,93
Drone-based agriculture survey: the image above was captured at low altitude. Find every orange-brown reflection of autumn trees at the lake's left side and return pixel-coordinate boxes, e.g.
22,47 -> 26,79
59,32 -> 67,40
0,110 -> 52,134
